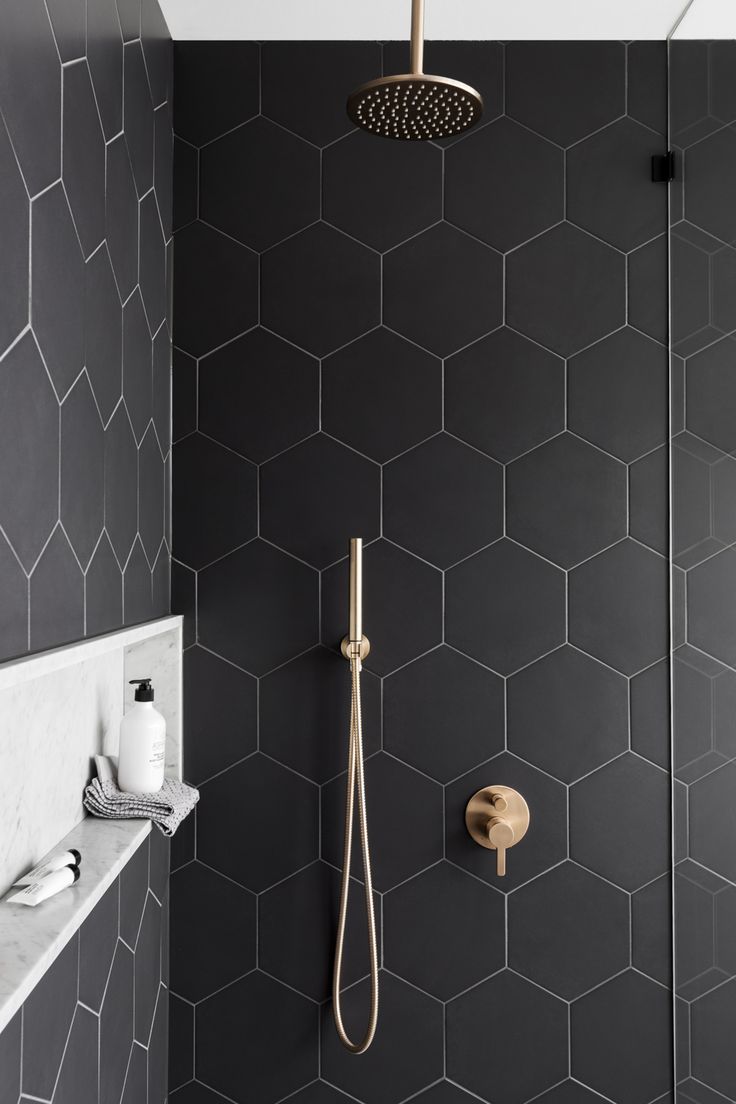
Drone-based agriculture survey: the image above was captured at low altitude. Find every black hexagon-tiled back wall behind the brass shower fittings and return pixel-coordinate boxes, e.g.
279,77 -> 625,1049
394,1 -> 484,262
171,43 -> 672,1104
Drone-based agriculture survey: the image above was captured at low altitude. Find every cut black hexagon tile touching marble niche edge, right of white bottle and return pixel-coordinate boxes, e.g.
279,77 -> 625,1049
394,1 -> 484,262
184,647 -> 257,786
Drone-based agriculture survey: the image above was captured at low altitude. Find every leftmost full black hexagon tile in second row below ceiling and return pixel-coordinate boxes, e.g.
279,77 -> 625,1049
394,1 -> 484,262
200,117 -> 320,251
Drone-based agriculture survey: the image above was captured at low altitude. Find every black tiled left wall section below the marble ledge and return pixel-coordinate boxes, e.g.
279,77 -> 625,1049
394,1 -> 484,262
0,829 -> 169,1104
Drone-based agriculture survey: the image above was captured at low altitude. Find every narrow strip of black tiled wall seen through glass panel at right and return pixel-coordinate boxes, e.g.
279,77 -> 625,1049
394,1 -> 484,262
670,42 -> 736,1104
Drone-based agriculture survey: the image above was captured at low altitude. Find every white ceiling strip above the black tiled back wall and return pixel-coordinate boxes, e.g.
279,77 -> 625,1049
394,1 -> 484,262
160,0 -> 701,41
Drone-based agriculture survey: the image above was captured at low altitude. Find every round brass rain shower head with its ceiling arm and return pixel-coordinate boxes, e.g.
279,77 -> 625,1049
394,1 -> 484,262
348,0 -> 483,141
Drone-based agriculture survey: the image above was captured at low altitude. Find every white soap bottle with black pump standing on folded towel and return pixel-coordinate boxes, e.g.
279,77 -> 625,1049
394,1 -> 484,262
118,679 -> 167,794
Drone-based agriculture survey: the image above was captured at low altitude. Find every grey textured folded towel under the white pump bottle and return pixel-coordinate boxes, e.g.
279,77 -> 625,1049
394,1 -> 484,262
84,755 -> 200,836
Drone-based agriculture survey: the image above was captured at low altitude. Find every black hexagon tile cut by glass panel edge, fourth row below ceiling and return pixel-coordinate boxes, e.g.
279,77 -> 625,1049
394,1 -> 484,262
567,327 -> 668,463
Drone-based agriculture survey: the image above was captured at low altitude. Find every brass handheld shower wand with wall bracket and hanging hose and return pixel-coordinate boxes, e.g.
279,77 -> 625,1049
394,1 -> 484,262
332,537 -> 378,1054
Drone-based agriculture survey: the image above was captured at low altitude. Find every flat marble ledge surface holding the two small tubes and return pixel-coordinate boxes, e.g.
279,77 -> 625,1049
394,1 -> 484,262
0,817 -> 151,1031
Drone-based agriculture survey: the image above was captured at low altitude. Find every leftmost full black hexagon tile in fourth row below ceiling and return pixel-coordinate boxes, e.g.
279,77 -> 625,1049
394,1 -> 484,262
199,329 -> 319,464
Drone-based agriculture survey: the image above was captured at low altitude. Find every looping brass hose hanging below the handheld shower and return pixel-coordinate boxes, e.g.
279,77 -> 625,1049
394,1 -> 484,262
332,656 -> 378,1054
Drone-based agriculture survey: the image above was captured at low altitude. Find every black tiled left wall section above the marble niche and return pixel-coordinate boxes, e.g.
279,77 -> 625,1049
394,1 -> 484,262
0,0 -> 173,659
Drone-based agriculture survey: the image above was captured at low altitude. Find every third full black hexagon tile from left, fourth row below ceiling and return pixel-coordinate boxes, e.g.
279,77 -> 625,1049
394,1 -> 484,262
445,328 -> 565,463
